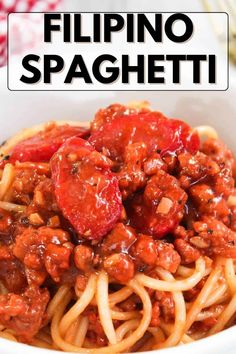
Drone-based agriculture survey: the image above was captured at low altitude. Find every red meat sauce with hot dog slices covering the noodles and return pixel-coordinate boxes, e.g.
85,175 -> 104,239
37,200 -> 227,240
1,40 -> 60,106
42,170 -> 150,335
0,105 -> 236,345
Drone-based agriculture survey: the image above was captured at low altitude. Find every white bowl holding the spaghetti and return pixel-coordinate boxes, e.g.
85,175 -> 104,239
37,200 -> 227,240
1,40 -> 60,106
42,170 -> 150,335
0,69 -> 236,354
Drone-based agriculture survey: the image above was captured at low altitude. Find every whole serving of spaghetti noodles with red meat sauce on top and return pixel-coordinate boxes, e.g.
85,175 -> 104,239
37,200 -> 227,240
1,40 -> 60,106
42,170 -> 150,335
0,103 -> 236,354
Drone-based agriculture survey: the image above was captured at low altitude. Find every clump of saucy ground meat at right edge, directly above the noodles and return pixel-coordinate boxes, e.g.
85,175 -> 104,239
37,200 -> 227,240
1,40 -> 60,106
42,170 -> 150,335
193,217 -> 236,259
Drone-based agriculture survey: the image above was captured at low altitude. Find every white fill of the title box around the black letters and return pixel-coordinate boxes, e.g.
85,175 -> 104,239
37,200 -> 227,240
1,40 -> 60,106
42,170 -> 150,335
9,13 -> 227,90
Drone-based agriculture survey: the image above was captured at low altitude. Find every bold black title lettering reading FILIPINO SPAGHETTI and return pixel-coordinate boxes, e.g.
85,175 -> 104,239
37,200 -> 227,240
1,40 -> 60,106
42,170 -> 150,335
20,13 -> 216,88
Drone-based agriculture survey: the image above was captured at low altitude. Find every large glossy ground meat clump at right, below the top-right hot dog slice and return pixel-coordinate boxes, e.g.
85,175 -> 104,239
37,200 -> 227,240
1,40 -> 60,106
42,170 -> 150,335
178,152 -> 234,222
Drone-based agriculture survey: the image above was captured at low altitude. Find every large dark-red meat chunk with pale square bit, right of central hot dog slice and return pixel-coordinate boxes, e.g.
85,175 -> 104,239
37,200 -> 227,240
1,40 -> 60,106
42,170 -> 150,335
127,170 -> 187,238
